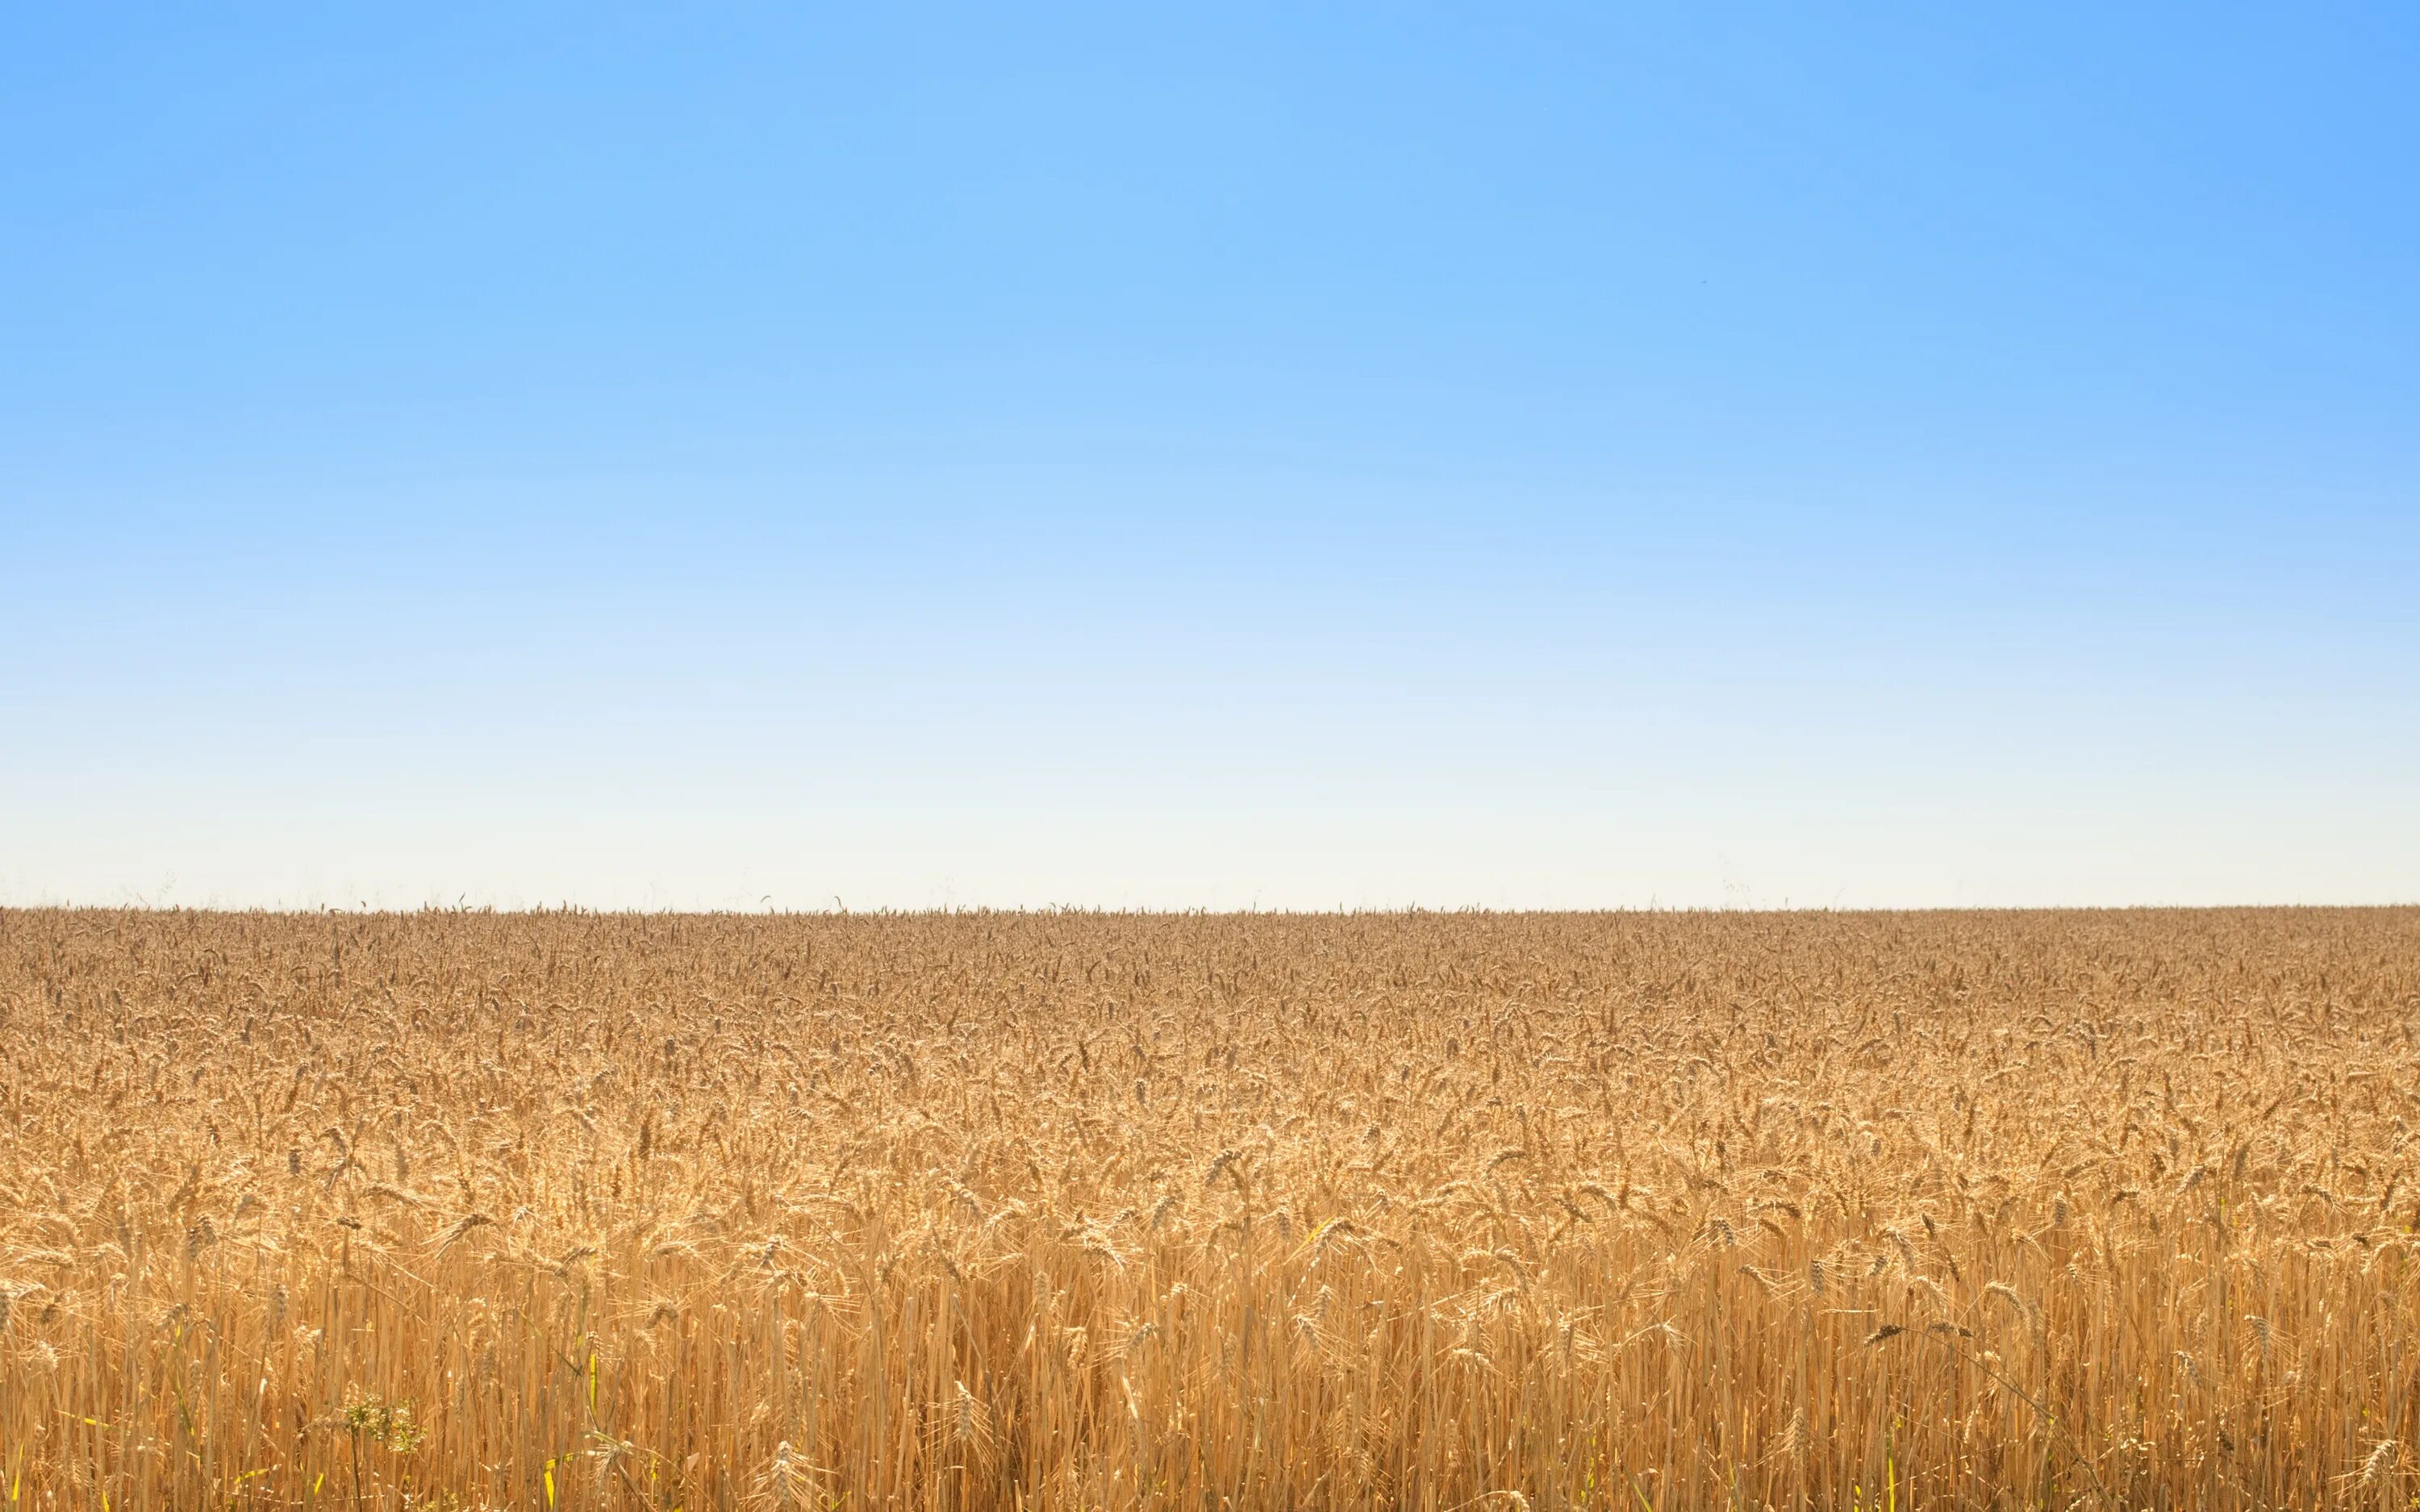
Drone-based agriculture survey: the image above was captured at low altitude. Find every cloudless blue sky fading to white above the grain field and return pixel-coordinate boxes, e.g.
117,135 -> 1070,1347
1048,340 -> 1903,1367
0,2 -> 2420,907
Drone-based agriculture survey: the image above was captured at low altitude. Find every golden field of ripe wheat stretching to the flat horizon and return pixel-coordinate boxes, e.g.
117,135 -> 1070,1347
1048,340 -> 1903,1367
0,910 -> 2420,1512
